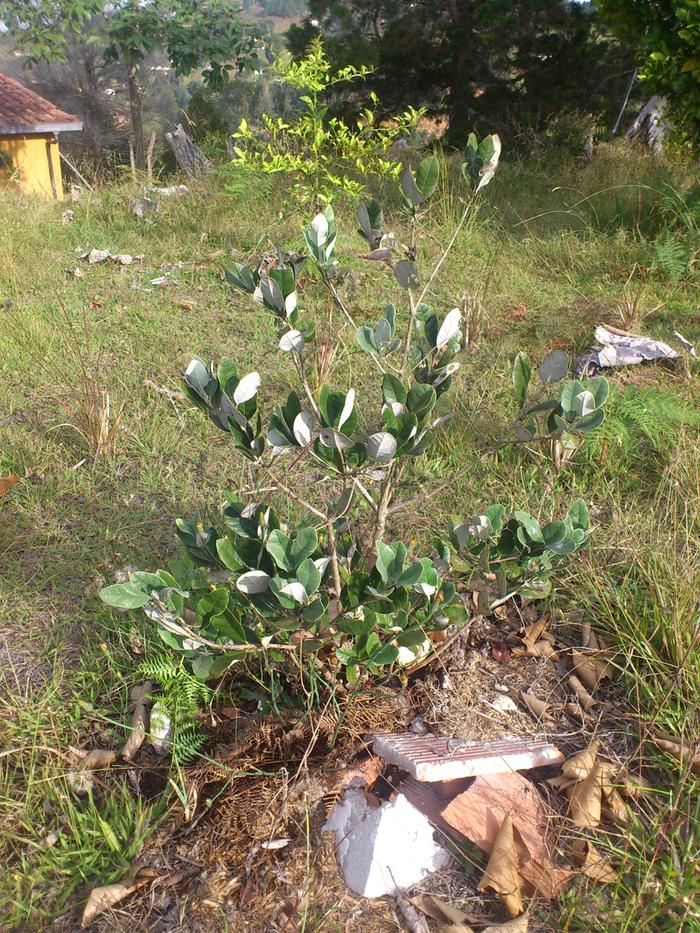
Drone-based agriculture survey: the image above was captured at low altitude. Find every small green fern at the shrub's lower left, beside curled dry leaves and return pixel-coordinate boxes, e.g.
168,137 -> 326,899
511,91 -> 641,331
137,655 -> 212,765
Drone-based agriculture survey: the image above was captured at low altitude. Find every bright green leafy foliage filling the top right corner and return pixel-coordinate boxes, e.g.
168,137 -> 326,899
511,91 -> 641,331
600,0 -> 700,150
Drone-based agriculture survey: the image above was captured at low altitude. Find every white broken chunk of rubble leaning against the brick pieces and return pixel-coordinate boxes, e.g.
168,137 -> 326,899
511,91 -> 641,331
323,789 -> 451,897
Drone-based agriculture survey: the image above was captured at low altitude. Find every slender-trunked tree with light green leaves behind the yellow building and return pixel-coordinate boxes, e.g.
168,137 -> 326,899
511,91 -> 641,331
0,0 -> 258,168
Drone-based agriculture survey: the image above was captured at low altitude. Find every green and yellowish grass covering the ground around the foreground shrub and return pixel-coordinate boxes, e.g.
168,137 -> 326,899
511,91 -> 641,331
0,147 -> 700,933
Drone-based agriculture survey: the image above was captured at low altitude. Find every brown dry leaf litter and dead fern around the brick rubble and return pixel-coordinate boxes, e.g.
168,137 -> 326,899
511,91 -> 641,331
61,606 -> 660,933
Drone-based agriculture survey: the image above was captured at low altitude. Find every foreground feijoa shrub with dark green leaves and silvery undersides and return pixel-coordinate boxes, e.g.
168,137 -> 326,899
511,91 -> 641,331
101,136 -> 608,699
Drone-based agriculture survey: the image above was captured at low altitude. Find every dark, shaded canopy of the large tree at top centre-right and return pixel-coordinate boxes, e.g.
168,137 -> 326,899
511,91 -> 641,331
288,0 -> 628,145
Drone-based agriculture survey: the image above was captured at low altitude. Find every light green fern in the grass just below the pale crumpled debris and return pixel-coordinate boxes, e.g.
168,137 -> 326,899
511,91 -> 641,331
586,386 -> 700,456
